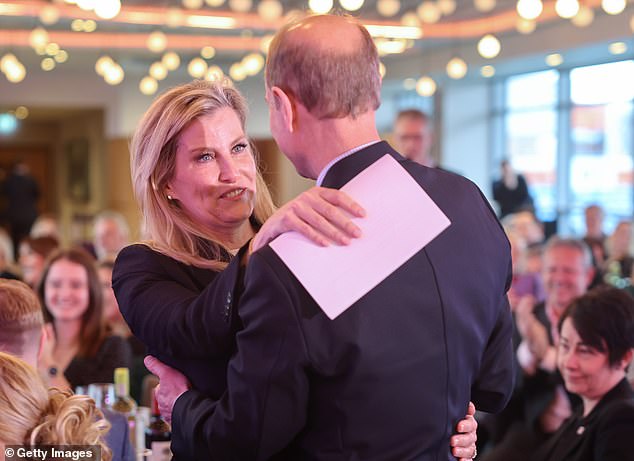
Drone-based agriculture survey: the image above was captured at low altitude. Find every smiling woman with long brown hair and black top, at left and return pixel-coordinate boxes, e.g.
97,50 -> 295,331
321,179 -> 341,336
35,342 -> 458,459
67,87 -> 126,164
38,248 -> 132,388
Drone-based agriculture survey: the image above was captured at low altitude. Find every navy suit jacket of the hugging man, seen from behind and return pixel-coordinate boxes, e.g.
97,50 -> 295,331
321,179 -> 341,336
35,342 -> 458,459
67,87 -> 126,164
172,142 -> 513,461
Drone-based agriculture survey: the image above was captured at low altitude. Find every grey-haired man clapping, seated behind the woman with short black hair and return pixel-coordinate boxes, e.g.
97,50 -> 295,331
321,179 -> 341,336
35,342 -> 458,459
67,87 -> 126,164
482,236 -> 594,461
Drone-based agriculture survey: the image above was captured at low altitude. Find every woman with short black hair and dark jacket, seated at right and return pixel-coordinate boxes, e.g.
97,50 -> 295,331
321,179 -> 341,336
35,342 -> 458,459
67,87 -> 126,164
532,288 -> 634,461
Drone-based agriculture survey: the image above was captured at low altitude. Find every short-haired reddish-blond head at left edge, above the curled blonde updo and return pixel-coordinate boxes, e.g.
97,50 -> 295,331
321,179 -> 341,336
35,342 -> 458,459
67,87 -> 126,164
0,279 -> 44,365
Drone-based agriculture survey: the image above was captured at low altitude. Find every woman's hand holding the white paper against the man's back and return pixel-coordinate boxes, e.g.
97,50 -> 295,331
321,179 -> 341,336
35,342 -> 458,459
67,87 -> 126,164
251,186 -> 365,251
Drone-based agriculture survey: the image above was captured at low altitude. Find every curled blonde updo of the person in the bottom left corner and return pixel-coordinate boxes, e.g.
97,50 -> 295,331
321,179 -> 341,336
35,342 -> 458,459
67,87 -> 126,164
0,352 -> 111,461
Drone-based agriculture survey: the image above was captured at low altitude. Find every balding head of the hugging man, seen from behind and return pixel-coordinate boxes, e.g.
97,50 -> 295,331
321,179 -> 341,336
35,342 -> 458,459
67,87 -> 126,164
266,15 -> 381,177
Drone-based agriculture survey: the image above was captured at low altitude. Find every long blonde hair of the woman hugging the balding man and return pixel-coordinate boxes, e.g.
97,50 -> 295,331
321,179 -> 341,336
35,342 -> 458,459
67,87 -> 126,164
130,80 -> 275,270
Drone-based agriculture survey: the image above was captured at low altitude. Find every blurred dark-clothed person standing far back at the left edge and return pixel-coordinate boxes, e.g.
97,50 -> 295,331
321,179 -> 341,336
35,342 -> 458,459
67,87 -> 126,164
1,161 -> 40,252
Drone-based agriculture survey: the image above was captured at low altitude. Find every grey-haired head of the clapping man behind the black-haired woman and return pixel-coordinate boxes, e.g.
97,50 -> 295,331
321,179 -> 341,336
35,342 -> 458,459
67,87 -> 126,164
542,236 -> 594,317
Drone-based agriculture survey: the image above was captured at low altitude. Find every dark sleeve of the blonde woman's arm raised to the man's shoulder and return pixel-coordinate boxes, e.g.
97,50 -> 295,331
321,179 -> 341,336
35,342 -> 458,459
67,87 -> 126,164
112,245 -> 240,358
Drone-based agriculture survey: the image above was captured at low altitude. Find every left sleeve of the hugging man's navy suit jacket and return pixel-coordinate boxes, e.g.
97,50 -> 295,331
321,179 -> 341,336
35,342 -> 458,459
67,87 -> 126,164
172,250 -> 308,461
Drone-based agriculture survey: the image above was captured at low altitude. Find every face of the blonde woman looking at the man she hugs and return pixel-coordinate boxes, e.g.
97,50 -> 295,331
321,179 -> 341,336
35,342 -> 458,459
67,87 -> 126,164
167,107 -> 256,234
